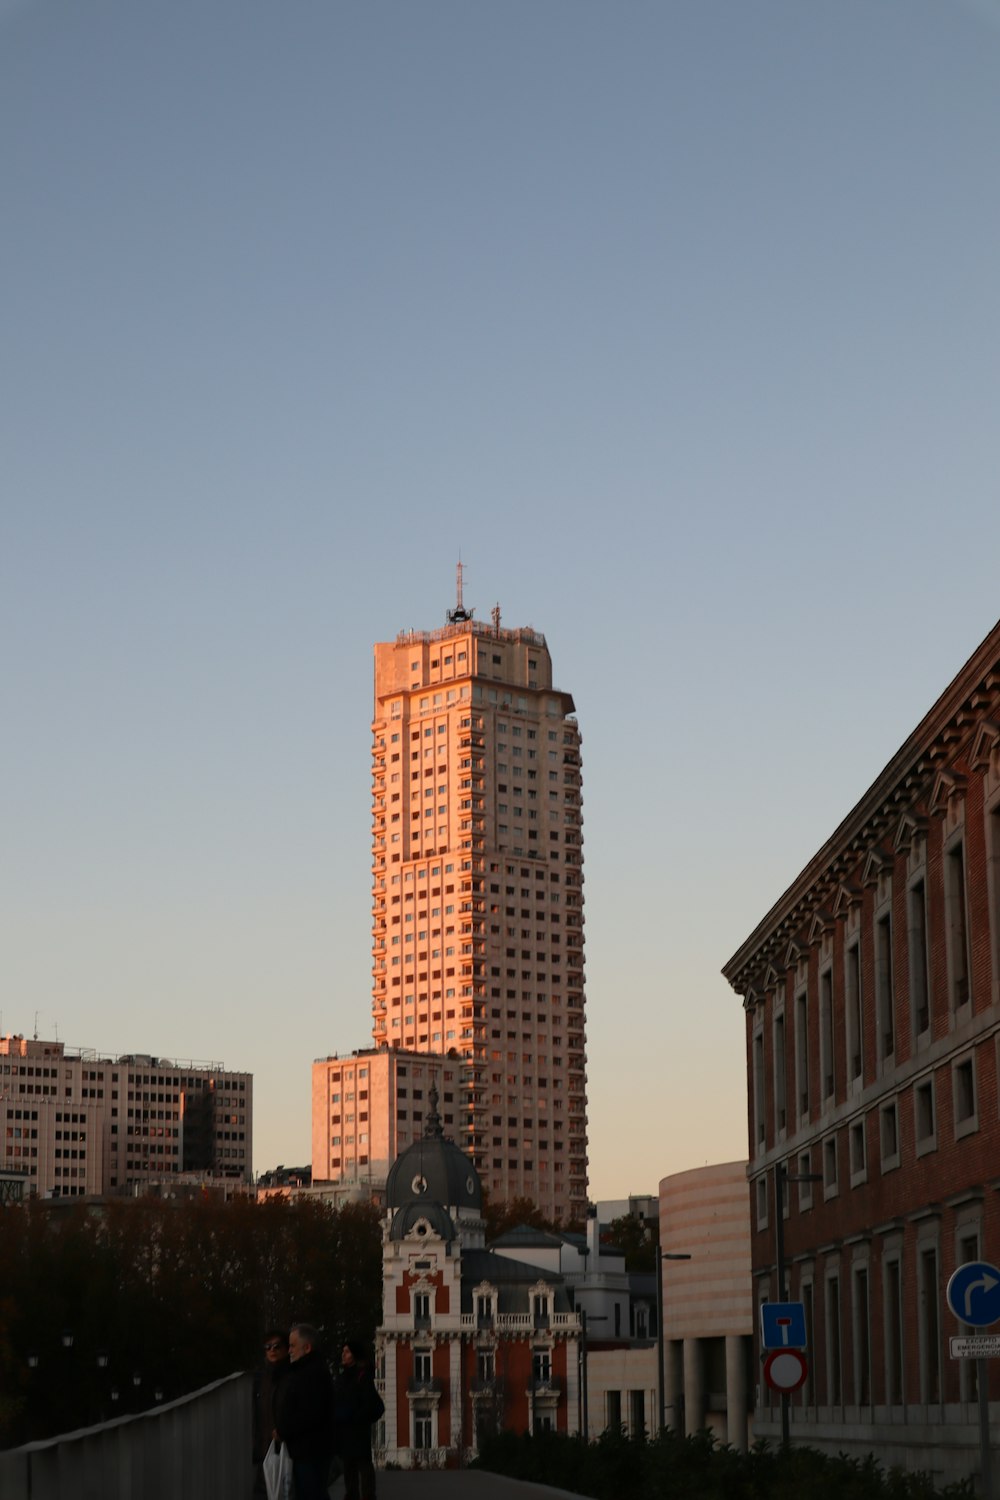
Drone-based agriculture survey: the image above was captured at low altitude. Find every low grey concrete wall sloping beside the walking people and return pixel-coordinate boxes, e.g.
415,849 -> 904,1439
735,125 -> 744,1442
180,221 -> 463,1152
0,1376 -> 252,1500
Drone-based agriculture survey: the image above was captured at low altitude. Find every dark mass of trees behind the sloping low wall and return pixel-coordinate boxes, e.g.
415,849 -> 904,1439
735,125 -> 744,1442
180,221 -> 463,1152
0,1196 -> 382,1446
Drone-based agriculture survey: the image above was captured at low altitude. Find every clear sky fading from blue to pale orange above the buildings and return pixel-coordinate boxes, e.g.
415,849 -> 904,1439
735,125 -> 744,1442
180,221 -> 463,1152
0,0 -> 1000,1197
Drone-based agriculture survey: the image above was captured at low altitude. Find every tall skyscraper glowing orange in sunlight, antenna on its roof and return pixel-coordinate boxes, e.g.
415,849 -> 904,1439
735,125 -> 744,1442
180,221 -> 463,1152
372,564 -> 588,1221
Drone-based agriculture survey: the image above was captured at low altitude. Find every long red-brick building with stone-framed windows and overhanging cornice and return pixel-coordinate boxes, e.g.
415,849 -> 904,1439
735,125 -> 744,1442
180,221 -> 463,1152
723,626 -> 1000,1478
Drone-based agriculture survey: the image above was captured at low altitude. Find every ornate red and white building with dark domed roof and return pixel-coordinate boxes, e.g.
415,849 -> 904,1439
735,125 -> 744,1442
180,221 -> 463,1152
376,1091 -> 582,1467
